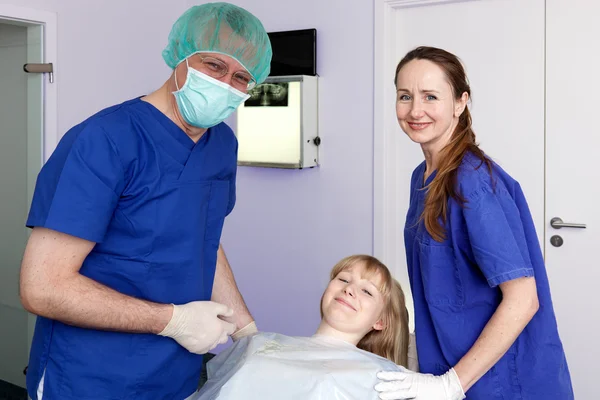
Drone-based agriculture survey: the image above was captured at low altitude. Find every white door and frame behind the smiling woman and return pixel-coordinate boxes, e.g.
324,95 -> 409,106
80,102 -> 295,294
374,0 -> 600,400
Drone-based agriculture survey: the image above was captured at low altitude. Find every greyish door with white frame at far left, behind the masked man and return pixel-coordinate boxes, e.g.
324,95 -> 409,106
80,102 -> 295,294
0,4 -> 56,390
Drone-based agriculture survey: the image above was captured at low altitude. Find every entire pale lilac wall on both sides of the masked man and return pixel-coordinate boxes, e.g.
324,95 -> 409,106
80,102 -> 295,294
5,0 -> 373,335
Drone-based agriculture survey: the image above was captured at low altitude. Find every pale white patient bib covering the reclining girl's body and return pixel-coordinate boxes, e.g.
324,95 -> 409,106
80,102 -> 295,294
194,333 -> 400,400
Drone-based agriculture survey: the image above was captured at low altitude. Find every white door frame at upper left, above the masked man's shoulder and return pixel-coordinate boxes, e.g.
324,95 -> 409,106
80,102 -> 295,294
0,4 -> 60,163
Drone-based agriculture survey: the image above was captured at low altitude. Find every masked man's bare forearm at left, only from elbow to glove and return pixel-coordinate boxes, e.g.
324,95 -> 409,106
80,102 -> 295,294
26,273 -> 173,333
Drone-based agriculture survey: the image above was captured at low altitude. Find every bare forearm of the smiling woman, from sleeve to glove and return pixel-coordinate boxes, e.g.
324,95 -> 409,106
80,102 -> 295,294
454,299 -> 537,392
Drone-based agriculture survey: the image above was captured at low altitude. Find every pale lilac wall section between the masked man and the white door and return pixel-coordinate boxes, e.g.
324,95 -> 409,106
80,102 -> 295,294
188,0 -> 373,335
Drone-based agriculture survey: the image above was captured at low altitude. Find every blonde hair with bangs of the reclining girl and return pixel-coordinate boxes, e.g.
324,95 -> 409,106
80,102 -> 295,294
321,254 -> 409,367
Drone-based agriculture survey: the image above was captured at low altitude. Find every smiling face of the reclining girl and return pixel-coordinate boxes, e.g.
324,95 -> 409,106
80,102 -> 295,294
321,263 -> 385,342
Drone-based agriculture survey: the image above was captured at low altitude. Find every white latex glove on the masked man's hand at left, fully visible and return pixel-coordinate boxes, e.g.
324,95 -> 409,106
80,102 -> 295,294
159,301 -> 235,354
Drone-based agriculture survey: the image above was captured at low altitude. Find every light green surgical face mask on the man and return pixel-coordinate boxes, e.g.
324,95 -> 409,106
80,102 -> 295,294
173,59 -> 250,128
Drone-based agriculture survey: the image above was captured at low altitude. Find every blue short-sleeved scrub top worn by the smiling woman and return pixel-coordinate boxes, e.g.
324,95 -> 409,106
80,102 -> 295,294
404,153 -> 573,400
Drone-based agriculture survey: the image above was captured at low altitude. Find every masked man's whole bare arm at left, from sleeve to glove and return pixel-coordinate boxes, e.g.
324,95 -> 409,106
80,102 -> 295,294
20,228 -> 173,333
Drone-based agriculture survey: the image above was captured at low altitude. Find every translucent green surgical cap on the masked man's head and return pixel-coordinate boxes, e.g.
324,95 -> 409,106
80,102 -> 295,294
162,3 -> 273,83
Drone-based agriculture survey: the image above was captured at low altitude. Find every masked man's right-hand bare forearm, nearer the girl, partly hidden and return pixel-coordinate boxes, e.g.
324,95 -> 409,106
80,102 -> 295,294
211,246 -> 254,329
